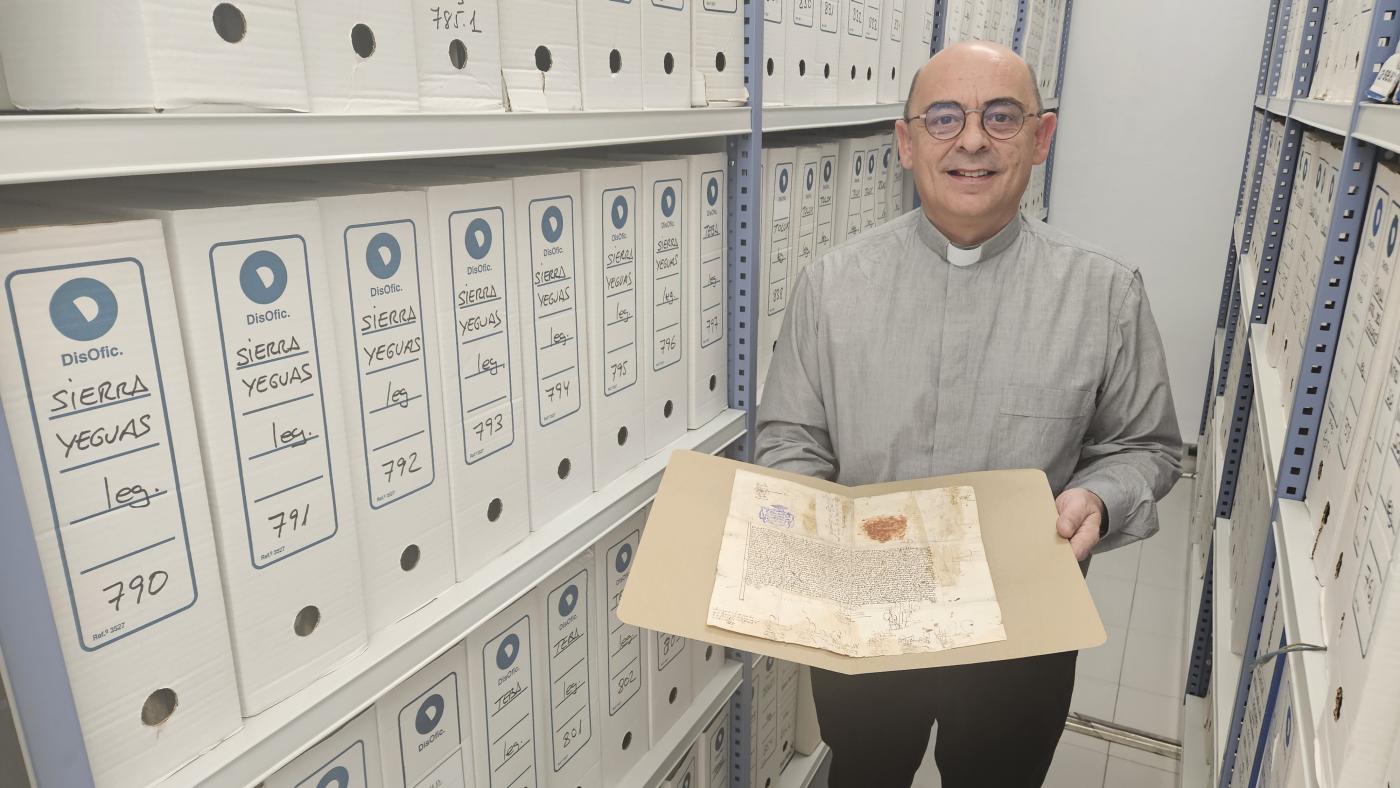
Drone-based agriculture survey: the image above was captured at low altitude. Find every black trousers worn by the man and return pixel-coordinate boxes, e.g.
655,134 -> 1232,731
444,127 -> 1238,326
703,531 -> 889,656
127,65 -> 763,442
812,651 -> 1078,788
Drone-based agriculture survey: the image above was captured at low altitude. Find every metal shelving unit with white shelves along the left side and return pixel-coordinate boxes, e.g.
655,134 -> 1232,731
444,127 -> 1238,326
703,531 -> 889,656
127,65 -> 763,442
0,0 -> 1072,788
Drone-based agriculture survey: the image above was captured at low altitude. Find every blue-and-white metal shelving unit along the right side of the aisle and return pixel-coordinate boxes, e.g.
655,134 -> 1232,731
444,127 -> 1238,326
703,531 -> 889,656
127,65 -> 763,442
1183,0 -> 1400,788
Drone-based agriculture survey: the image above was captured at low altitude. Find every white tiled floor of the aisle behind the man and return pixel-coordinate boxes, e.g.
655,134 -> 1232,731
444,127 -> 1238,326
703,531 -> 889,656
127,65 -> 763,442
914,480 -> 1194,788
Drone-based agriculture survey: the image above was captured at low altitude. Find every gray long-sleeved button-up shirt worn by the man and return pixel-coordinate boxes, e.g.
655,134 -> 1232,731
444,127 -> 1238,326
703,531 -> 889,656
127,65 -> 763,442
755,210 -> 1182,551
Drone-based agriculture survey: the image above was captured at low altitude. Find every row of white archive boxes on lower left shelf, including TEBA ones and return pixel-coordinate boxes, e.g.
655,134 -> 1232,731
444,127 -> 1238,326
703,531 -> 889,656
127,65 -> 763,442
265,511 -> 744,788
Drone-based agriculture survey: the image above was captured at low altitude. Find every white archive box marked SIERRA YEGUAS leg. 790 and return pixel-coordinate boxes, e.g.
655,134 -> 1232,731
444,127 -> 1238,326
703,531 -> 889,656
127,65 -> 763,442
0,206 -> 241,788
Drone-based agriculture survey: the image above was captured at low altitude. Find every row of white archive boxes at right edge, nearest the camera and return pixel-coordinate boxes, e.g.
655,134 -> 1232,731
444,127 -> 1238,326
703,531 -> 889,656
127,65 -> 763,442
1288,151 -> 1400,785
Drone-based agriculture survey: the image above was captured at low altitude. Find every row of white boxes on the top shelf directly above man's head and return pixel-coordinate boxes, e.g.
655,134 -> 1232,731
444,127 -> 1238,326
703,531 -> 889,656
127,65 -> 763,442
944,0 -> 1065,97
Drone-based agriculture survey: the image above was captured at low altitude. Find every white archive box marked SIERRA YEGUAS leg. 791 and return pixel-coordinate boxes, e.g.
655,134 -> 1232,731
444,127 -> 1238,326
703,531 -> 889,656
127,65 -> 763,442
68,183 -> 365,715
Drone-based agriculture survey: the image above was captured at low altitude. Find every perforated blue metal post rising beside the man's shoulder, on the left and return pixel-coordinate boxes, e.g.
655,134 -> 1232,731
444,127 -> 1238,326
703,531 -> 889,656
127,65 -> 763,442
725,0 -> 763,462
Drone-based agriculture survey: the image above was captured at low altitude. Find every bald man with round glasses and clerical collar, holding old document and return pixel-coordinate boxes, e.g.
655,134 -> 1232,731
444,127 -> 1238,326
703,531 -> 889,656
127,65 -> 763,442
756,42 -> 1182,788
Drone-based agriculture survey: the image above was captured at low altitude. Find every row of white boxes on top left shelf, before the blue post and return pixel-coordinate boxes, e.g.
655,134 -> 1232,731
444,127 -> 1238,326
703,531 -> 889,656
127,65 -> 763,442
0,0 -> 756,113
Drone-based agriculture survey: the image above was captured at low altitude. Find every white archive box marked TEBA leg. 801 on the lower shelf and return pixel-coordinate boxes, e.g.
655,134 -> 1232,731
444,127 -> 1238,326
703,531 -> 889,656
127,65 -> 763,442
538,550 -> 602,788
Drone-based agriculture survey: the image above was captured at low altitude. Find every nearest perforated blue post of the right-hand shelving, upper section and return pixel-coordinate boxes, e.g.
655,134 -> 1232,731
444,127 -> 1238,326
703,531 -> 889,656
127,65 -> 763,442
1278,0 -> 1400,500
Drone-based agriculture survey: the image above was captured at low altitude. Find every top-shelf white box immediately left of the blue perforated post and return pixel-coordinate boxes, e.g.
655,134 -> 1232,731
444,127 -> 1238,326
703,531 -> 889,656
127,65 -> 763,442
690,0 -> 749,106
